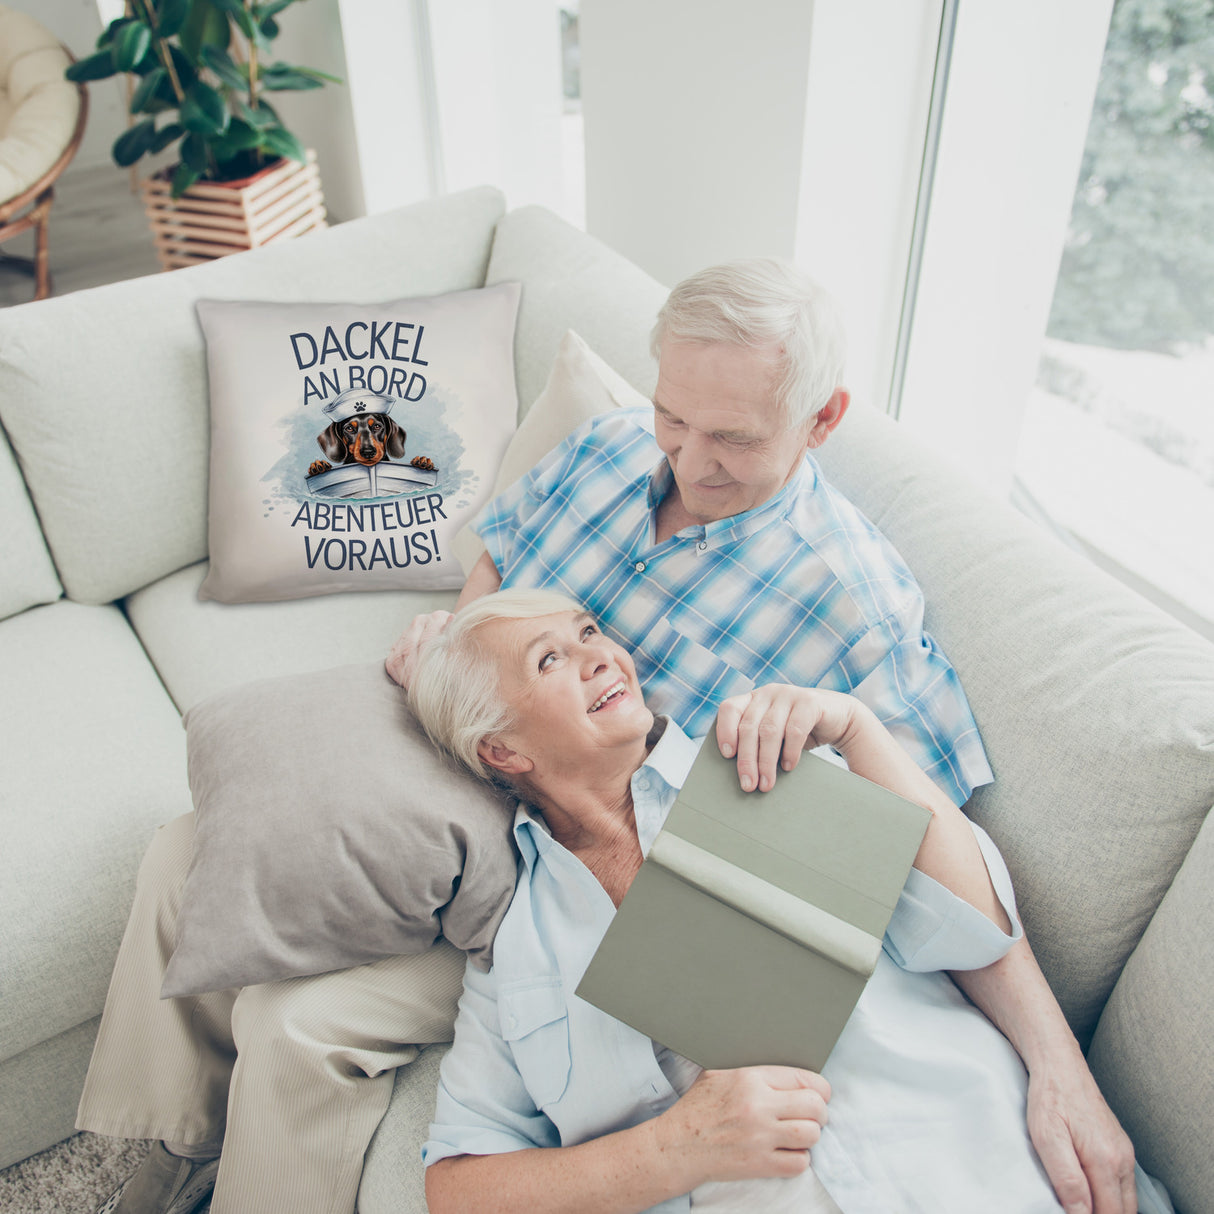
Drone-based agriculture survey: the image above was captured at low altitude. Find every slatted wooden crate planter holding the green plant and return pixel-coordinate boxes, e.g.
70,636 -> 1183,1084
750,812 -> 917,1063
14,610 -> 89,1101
140,152 -> 328,270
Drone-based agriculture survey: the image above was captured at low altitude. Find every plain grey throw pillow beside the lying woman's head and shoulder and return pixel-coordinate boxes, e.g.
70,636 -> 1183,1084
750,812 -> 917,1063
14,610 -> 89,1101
163,662 -> 516,995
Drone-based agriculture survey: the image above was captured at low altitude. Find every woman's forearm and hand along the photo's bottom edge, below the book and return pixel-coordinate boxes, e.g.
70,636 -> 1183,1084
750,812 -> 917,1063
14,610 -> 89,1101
426,1066 -> 830,1214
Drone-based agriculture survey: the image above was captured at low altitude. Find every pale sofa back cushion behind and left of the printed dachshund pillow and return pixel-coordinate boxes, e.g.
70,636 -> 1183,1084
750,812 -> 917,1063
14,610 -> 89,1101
0,189 -> 503,603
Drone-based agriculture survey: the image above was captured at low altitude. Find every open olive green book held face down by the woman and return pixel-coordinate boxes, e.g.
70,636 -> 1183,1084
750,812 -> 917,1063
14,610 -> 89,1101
577,737 -> 931,1071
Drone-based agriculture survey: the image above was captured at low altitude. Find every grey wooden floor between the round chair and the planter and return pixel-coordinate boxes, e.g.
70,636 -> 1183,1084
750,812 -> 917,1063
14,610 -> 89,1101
0,164 -> 160,307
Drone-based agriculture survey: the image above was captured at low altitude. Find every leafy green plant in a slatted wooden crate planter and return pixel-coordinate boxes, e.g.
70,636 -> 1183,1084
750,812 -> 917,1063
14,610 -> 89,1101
67,0 -> 340,268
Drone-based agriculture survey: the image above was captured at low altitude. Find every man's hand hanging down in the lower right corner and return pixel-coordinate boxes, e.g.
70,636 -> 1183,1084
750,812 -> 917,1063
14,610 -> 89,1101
1028,1059 -> 1138,1214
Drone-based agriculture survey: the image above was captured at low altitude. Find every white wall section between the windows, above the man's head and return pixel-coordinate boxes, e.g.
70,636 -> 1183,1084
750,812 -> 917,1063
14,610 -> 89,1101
580,0 -> 813,283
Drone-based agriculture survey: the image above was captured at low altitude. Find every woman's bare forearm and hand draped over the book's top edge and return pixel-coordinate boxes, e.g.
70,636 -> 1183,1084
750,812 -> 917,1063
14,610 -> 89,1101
716,683 -> 1012,934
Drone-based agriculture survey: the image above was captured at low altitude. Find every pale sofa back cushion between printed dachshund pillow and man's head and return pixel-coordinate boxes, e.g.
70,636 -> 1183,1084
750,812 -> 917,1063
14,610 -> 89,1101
486,206 -> 668,414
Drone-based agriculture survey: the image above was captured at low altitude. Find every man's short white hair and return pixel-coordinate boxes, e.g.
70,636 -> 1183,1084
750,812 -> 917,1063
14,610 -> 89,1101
649,257 -> 846,426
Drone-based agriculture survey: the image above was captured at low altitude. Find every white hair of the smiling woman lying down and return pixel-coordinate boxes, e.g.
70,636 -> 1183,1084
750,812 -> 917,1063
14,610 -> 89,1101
409,590 -> 583,779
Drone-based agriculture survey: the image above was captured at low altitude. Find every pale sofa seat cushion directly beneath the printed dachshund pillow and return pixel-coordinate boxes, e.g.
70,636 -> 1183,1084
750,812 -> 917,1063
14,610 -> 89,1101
123,565 -> 455,713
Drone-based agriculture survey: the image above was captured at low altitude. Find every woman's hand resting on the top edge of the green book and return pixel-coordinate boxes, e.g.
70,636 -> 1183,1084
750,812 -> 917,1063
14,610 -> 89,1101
716,683 -> 867,793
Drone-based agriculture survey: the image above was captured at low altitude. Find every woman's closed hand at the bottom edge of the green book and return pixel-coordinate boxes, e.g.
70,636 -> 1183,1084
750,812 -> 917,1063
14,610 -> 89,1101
654,1066 -> 830,1189
